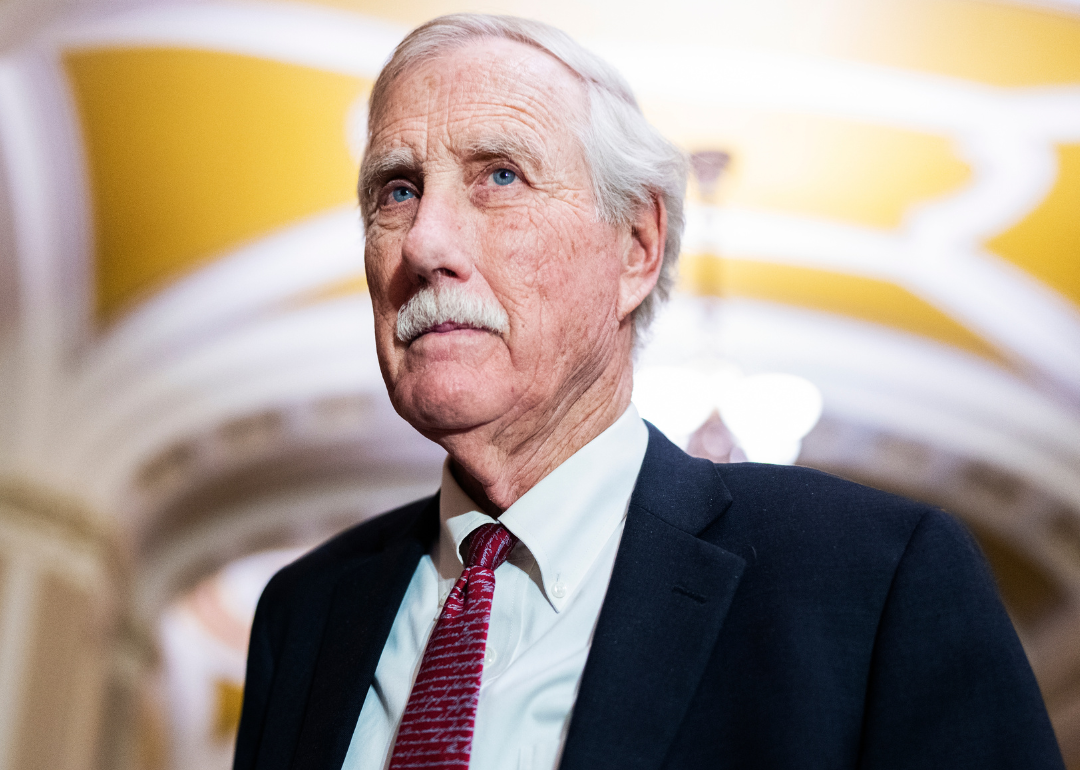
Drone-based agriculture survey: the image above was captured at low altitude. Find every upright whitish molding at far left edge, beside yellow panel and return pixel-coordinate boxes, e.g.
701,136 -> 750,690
0,49 -> 93,470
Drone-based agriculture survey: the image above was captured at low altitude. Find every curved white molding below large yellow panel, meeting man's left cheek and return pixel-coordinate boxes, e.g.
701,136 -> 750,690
59,297 -> 384,510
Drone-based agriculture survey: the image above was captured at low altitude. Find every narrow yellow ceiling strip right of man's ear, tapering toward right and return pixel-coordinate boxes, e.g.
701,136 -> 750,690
679,254 -> 1003,363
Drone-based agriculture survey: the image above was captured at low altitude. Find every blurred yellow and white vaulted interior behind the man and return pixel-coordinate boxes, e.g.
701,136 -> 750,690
0,0 -> 1080,770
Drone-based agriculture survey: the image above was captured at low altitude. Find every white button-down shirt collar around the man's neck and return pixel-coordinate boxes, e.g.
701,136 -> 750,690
436,404 -> 649,612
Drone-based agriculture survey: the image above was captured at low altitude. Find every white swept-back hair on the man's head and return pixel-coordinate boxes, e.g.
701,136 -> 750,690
359,13 -> 687,337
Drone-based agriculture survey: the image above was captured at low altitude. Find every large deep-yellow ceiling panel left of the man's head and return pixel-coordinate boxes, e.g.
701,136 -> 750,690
65,49 -> 370,323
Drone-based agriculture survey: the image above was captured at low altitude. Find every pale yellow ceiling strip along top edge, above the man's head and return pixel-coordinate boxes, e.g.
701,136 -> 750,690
293,0 -> 1080,85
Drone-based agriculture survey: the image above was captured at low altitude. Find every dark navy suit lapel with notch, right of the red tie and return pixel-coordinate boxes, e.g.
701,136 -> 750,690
559,425 -> 745,770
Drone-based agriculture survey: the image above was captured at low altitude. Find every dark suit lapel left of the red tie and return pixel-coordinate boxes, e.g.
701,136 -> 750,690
291,496 -> 438,770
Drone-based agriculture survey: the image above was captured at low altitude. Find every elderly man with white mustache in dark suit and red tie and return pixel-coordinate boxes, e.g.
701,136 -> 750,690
235,15 -> 1062,770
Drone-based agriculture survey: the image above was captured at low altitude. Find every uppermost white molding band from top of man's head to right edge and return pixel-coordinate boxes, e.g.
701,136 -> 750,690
600,41 -> 1080,141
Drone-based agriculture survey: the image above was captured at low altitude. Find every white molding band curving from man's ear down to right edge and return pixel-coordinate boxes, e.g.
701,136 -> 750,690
685,205 -> 1080,386
